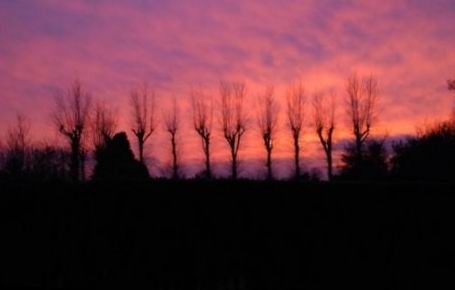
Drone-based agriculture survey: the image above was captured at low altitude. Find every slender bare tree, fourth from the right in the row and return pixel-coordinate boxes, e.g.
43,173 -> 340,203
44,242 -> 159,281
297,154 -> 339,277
258,87 -> 279,180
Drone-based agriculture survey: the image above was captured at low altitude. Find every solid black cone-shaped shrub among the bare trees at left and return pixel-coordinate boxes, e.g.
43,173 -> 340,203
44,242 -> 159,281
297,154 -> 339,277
93,132 -> 149,180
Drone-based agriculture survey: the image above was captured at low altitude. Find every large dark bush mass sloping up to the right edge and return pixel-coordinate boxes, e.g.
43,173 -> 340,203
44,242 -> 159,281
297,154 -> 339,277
392,122 -> 455,181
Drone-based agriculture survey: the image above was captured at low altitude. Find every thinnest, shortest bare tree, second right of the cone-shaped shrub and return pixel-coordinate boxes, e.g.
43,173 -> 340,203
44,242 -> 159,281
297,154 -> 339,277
164,98 -> 180,179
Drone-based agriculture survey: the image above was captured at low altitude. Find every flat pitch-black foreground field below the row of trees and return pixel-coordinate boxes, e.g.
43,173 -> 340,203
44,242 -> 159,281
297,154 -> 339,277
0,181 -> 455,289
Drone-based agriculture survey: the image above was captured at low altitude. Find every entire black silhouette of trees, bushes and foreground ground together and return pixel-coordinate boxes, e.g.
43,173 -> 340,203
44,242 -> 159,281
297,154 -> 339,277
0,77 -> 455,290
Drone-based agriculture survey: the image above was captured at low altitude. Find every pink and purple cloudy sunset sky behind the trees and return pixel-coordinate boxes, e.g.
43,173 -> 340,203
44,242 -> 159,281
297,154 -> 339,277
0,0 -> 455,176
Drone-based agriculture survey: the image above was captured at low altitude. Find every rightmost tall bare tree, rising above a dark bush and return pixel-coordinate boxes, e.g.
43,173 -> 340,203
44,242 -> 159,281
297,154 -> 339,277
346,75 -> 378,158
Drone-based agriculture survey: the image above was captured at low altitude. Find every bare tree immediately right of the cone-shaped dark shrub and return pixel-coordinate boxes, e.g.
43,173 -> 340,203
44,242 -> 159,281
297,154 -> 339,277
130,84 -> 156,164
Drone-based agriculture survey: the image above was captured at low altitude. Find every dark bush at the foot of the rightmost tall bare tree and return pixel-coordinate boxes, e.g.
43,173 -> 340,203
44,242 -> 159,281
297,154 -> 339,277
339,139 -> 388,180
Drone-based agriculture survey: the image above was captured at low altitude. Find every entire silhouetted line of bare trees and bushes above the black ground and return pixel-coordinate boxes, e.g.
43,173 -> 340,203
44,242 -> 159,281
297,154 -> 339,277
0,75 -> 455,181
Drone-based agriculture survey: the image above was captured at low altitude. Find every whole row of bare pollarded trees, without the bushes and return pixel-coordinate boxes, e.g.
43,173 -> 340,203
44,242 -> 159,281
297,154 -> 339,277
1,75 -> 378,181
